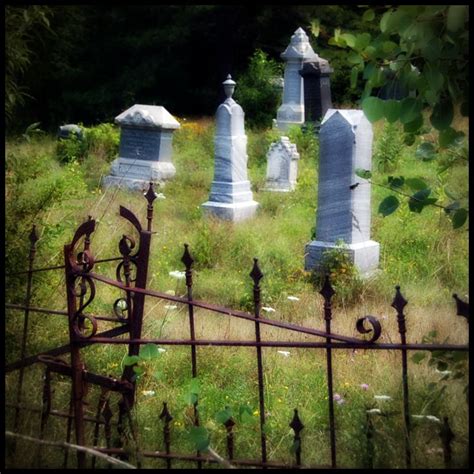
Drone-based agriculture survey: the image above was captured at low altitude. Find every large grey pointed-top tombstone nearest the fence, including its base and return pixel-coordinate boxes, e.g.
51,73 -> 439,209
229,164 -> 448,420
305,109 -> 380,275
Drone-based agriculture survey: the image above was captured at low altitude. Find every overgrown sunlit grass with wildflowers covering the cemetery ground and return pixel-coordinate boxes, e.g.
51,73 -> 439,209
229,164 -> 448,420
6,113 -> 468,468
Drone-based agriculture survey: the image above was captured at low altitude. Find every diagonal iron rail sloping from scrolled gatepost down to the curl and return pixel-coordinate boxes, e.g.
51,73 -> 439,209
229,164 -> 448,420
89,272 -> 366,344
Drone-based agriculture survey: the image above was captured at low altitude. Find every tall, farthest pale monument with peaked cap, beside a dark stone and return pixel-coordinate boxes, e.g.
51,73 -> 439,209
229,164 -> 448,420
276,28 -> 318,131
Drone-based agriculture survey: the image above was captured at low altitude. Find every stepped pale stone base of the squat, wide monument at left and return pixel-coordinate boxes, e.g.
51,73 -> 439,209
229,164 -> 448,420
102,158 -> 176,190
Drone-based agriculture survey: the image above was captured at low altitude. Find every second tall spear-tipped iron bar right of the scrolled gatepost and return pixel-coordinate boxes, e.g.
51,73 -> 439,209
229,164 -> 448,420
250,258 -> 267,469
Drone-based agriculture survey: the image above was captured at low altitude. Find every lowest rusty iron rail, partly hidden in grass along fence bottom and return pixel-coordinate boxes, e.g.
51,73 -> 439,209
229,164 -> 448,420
94,446 -> 331,469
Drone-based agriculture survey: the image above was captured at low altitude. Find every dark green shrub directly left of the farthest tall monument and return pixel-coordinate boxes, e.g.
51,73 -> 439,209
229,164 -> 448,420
234,49 -> 282,128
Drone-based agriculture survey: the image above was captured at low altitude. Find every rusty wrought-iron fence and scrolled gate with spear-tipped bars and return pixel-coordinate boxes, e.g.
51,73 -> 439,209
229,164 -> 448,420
6,183 -> 469,468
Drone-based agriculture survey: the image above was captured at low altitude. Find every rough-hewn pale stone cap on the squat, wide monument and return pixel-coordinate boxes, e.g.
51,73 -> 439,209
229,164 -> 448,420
115,104 -> 180,129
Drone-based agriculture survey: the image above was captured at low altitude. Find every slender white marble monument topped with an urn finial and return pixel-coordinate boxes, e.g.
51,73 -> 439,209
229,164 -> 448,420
202,74 -> 258,221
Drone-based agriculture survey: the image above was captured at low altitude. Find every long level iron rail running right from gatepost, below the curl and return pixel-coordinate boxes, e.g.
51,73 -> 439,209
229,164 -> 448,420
84,337 -> 469,351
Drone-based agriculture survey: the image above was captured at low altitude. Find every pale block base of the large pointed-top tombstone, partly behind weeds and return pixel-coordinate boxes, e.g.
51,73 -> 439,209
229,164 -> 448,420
304,240 -> 380,276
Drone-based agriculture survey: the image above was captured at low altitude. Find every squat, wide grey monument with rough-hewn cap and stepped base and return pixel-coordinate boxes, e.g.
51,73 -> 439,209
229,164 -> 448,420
103,104 -> 180,189
